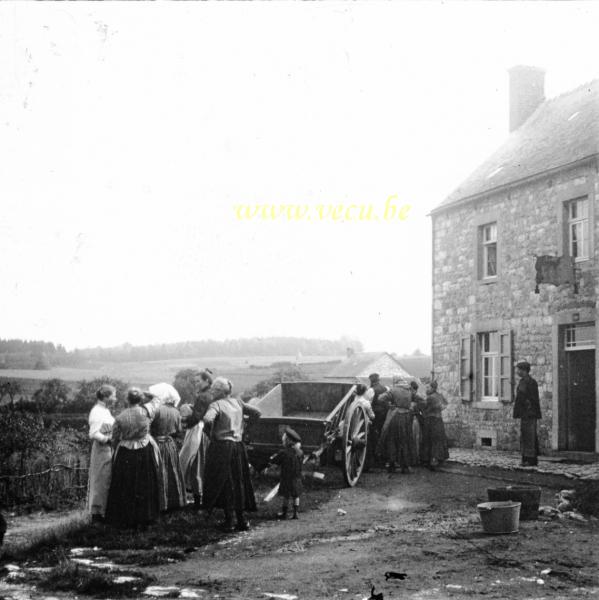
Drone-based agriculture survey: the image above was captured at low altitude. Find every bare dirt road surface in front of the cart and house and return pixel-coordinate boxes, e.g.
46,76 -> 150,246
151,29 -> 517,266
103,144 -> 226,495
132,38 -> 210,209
146,469 -> 599,600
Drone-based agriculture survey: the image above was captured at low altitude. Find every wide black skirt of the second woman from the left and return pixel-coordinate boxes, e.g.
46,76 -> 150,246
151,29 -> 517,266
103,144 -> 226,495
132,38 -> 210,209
106,444 -> 160,527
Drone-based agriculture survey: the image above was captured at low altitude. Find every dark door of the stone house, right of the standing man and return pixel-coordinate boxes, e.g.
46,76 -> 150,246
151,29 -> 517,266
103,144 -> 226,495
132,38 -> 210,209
565,350 -> 596,452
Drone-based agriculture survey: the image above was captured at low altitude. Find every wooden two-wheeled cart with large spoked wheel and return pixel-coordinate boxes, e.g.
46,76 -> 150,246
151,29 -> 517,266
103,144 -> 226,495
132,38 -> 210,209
245,381 -> 368,486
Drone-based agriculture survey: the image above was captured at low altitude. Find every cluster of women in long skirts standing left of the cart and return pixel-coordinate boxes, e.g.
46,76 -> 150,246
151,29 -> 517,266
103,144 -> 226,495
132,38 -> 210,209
88,370 -> 260,530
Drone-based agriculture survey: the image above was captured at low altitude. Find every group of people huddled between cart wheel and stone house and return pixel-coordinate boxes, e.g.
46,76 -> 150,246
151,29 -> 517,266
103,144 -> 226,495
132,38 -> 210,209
357,373 -> 449,473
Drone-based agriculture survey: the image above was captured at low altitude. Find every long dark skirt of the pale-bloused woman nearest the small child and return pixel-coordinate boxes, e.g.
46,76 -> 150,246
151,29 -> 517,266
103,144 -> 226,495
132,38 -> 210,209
204,440 -> 256,511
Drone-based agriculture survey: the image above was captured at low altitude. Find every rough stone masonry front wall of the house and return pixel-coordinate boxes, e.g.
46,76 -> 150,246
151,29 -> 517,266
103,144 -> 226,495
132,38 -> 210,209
432,159 -> 599,452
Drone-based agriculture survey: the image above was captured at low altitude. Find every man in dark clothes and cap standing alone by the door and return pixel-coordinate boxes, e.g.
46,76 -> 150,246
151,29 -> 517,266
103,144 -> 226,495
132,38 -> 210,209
514,360 -> 541,467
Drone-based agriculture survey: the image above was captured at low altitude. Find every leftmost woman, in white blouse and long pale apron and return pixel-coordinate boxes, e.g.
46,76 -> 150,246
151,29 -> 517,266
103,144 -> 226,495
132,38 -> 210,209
87,384 -> 116,523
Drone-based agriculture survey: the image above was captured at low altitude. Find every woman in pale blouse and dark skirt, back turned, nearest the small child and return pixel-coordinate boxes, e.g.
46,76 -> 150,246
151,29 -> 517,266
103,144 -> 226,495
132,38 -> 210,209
203,377 -> 260,531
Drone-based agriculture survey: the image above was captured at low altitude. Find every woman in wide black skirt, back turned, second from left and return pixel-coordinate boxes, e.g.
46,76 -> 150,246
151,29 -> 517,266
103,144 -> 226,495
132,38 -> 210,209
106,388 -> 162,527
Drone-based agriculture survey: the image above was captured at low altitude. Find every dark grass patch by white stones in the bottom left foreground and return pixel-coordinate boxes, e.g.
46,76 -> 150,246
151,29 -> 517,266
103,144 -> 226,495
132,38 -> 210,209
37,561 -> 154,598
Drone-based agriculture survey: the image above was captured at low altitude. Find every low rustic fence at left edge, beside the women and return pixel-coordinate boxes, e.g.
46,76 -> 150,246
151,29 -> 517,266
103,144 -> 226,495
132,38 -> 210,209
0,456 -> 88,509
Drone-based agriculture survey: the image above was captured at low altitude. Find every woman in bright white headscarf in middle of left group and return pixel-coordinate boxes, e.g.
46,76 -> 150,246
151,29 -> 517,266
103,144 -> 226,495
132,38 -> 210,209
148,383 -> 186,510
